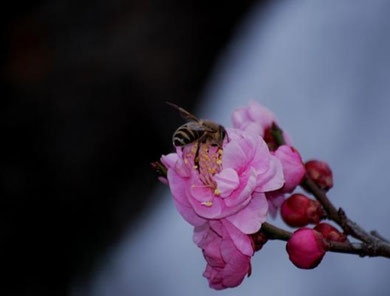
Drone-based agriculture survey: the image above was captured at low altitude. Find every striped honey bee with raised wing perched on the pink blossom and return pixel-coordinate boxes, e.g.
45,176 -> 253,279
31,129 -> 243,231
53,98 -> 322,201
166,102 -> 227,161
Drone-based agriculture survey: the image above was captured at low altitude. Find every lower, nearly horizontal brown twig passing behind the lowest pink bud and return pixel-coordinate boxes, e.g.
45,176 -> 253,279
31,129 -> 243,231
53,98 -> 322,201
260,222 -> 390,258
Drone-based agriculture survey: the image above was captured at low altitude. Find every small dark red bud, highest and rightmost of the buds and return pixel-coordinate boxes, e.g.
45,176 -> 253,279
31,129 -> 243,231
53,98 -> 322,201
305,160 -> 333,191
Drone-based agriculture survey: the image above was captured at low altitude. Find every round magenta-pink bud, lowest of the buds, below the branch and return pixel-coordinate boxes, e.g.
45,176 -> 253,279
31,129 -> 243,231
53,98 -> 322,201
286,227 -> 327,269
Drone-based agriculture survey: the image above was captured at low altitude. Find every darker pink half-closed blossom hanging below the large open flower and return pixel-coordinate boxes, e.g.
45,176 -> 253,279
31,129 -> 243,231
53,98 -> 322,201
193,219 -> 253,290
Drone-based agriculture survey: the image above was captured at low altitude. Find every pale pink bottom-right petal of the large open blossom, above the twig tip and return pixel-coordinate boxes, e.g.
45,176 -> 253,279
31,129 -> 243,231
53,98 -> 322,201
226,193 -> 268,234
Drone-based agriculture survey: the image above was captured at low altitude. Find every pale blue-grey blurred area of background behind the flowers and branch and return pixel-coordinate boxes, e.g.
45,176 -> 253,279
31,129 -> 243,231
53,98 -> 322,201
77,1 -> 390,296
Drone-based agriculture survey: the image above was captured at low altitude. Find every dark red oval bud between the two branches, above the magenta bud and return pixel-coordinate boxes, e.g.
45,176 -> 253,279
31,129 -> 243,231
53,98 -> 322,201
280,194 -> 325,227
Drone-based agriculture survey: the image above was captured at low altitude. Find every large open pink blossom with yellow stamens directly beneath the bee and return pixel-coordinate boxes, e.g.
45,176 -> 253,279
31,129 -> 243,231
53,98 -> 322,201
161,129 -> 284,234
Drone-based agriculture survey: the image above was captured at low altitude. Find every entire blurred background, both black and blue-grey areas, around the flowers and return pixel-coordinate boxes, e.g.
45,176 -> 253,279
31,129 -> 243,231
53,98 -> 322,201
0,0 -> 390,296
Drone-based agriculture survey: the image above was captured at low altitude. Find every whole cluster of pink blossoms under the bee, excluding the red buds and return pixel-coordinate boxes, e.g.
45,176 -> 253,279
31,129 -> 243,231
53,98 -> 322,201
161,102 -> 305,289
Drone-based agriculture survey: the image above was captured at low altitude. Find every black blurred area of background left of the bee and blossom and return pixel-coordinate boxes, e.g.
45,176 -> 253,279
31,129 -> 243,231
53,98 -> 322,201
0,0 -> 272,295
